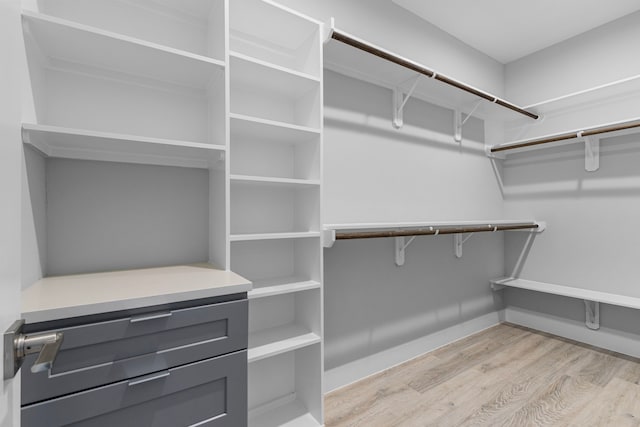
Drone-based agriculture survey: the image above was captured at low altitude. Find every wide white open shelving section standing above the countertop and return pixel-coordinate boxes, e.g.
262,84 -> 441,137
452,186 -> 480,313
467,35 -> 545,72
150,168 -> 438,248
22,0 -> 229,276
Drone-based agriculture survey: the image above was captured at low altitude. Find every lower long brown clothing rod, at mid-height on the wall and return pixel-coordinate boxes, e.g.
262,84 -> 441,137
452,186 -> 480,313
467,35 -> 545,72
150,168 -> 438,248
336,223 -> 539,240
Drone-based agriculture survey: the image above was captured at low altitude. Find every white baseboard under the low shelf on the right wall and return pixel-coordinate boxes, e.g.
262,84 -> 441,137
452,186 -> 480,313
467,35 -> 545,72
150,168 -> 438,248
504,307 -> 640,357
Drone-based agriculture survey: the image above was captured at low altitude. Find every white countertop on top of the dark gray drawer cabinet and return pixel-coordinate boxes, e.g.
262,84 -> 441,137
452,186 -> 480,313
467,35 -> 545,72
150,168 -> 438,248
22,265 -> 251,323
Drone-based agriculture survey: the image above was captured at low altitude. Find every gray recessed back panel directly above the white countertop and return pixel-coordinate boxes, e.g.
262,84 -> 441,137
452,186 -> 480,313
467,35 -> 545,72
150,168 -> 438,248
25,154 -> 209,276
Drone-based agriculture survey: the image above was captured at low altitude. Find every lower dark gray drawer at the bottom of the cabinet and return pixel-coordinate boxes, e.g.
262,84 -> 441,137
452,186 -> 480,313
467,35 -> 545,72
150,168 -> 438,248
22,351 -> 247,427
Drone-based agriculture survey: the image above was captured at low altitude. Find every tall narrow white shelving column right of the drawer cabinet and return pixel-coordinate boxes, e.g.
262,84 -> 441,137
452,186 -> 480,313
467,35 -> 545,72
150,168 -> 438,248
229,0 -> 323,426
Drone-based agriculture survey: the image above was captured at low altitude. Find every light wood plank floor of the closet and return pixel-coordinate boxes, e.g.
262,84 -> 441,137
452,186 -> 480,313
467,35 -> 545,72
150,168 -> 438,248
325,324 -> 640,427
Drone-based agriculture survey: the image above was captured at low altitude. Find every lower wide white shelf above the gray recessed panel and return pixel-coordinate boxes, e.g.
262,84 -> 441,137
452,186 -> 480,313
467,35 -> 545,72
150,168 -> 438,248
22,123 -> 225,168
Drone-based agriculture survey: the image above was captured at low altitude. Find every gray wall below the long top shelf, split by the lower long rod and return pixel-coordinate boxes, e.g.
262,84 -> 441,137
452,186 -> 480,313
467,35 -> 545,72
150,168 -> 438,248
323,70 -> 504,370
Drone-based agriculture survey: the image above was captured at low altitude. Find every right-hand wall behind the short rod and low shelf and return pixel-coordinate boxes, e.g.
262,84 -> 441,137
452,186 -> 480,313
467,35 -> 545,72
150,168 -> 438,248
504,13 -> 640,356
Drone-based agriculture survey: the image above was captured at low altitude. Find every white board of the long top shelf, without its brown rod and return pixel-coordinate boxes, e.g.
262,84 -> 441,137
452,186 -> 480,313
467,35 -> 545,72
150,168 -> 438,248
324,27 -> 535,123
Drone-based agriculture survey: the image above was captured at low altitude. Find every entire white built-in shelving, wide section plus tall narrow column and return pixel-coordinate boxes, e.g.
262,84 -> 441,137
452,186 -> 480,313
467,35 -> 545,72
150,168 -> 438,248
22,0 -> 323,426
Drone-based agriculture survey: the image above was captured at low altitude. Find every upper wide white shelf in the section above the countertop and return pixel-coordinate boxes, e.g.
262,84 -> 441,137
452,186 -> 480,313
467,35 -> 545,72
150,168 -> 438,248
22,11 -> 224,89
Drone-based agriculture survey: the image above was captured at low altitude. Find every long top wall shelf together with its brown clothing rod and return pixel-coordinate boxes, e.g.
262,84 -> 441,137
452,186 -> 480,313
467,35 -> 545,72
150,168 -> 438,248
324,22 -> 538,120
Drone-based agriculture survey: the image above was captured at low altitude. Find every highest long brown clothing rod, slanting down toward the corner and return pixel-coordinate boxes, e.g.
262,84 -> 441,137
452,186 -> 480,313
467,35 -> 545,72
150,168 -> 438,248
331,29 -> 539,120
